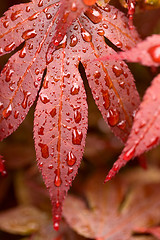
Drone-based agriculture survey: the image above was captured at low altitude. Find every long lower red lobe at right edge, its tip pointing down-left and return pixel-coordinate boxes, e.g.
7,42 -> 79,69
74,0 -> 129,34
105,74 -> 160,181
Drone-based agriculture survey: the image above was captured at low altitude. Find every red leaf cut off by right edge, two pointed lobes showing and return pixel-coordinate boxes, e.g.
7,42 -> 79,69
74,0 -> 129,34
105,35 -> 160,182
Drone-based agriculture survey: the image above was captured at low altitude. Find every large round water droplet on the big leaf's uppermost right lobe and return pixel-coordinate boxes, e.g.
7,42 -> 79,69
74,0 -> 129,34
85,6 -> 102,24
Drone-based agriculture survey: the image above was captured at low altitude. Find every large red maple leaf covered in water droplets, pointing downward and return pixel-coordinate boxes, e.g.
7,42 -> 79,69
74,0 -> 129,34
0,0 -> 139,229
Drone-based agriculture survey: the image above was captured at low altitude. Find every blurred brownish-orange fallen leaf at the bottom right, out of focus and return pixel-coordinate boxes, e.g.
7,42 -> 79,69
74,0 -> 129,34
63,168 -> 160,240
